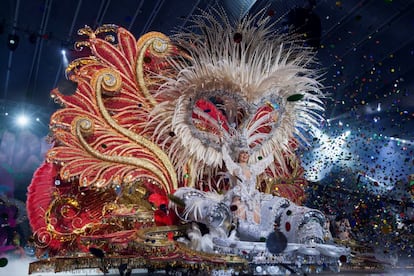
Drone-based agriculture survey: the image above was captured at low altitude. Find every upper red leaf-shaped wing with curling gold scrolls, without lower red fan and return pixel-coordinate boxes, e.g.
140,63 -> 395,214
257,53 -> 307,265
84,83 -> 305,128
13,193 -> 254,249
47,26 -> 177,192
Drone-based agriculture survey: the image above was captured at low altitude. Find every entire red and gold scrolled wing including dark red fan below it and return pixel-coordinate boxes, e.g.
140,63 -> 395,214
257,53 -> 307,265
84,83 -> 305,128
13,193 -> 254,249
27,25 -> 185,255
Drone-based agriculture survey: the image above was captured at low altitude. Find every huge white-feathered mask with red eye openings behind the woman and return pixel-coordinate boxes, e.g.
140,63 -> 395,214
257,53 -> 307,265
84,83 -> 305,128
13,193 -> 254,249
149,7 -> 324,185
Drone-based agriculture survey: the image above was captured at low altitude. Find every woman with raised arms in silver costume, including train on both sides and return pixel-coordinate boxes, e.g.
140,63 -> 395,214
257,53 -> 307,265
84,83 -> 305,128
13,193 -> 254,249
175,142 -> 326,244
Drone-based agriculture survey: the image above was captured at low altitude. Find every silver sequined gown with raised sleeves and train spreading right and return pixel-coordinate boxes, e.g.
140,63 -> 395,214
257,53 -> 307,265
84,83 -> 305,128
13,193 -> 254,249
223,147 -> 325,243
